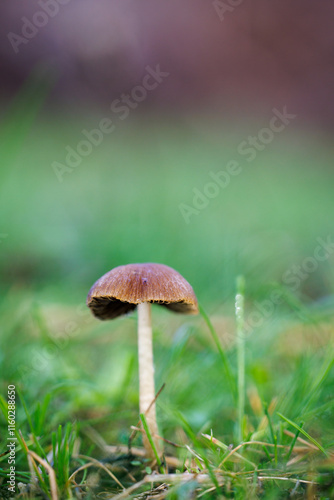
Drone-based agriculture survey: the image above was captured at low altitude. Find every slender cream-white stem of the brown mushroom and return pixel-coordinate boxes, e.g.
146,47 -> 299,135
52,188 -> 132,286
138,302 -> 161,458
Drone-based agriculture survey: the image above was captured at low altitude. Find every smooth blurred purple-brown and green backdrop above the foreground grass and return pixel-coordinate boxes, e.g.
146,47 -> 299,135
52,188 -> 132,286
0,0 -> 334,305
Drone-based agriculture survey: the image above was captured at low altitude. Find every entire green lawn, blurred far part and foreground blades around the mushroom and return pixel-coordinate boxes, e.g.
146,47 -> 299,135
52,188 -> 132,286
0,73 -> 334,500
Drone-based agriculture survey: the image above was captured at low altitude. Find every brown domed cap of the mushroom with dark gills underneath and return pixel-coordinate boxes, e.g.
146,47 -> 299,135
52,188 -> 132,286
87,263 -> 198,319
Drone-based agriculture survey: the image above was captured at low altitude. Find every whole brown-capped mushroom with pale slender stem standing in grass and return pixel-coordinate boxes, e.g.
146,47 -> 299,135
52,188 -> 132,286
87,263 -> 198,459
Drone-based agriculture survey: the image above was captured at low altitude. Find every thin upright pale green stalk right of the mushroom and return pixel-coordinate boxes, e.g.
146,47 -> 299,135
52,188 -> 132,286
235,276 -> 245,442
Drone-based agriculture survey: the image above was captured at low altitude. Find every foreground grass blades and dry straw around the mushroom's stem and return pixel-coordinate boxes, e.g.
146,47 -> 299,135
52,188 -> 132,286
1,284 -> 334,498
